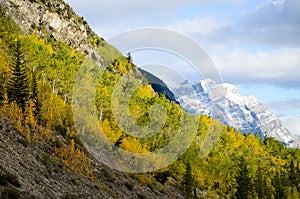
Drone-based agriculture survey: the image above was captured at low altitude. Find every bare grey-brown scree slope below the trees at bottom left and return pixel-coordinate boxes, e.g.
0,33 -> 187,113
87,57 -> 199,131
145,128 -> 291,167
0,118 -> 184,199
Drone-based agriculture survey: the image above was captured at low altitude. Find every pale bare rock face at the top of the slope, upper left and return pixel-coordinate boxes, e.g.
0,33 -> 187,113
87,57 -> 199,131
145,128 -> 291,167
0,0 -> 101,63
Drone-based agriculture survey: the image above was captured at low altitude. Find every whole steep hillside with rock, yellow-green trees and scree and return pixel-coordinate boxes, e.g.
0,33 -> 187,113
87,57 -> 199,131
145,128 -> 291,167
0,0 -> 300,198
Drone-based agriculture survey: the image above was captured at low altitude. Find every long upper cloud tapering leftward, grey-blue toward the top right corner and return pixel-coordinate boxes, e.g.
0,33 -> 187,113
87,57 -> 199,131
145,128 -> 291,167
159,0 -> 300,48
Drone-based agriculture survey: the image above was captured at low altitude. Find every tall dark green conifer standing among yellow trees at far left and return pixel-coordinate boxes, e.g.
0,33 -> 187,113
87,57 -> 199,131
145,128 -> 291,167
8,40 -> 29,111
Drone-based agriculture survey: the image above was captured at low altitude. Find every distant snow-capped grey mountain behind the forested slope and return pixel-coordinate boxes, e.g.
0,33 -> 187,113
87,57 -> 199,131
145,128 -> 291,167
171,79 -> 298,147
